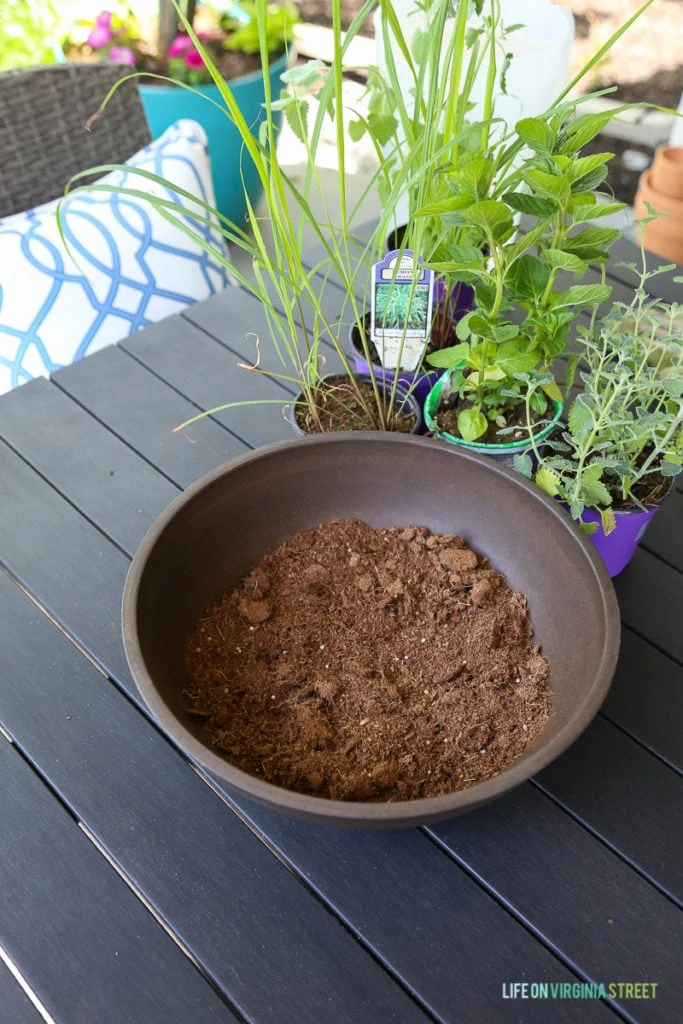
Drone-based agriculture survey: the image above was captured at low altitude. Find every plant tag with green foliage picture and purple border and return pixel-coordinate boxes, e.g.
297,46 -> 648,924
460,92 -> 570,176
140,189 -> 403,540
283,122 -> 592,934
370,249 -> 434,370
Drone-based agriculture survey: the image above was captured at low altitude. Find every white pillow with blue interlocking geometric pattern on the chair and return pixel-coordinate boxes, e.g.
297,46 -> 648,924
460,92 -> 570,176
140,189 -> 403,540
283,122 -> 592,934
0,121 -> 227,394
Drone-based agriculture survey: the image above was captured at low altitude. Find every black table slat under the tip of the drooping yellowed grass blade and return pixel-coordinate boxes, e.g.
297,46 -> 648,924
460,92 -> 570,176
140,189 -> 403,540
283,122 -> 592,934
52,345 -> 245,487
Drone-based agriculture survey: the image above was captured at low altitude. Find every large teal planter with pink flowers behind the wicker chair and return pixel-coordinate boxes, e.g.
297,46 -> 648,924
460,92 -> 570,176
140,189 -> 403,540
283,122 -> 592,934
140,53 -> 287,224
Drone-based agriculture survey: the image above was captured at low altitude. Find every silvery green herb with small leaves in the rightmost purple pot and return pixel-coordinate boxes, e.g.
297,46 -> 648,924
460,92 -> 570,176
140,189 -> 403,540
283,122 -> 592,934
515,247 -> 683,535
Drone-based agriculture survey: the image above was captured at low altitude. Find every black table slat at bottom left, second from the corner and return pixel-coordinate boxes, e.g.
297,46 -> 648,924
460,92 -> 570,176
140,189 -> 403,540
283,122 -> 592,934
0,741 -> 236,1024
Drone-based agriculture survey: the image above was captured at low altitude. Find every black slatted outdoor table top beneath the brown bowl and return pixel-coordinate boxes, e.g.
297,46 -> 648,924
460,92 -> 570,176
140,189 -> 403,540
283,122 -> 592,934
0,232 -> 683,1024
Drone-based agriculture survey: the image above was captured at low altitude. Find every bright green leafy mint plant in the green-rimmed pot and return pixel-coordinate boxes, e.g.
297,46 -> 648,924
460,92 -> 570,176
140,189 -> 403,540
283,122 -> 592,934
418,104 -> 624,441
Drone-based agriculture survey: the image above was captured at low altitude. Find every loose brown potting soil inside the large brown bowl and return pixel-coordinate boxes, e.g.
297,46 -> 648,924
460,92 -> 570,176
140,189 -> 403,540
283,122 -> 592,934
186,519 -> 550,801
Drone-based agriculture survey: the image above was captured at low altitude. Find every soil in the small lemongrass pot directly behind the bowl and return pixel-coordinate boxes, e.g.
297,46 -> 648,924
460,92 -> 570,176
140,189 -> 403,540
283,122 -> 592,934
294,376 -> 416,434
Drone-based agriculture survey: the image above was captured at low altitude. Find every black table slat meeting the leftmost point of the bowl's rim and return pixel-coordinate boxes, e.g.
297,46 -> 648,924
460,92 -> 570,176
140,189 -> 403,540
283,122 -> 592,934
0,438 -> 133,693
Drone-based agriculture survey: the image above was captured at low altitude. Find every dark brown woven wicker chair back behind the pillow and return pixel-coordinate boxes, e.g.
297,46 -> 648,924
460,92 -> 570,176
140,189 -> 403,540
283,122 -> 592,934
0,63 -> 151,217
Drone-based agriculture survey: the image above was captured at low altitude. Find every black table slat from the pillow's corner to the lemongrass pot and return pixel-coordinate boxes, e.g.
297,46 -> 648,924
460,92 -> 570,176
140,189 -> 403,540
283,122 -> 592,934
122,307 -> 296,445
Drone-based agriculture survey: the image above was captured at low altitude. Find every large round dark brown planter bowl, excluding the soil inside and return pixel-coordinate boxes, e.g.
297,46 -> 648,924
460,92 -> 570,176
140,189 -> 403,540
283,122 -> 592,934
123,431 -> 620,828
